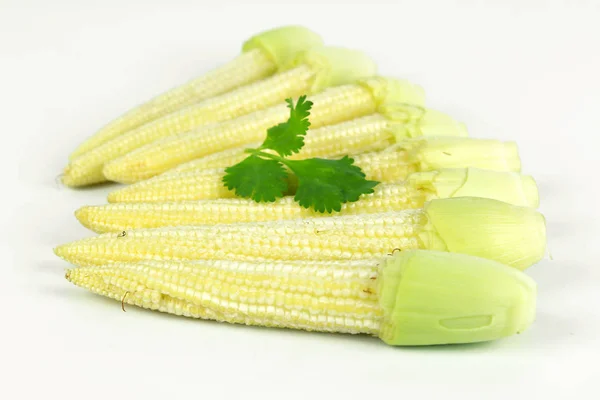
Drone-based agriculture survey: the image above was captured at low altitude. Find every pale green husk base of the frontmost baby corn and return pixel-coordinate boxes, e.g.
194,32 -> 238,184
378,250 -> 536,346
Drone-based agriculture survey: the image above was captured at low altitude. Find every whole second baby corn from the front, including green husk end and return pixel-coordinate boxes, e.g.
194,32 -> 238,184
55,197 -> 546,269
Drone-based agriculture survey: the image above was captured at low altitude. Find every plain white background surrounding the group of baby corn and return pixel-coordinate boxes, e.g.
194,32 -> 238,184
0,0 -> 600,399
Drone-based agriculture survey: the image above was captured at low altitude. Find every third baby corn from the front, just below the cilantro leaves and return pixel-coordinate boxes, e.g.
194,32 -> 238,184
82,168 -> 538,233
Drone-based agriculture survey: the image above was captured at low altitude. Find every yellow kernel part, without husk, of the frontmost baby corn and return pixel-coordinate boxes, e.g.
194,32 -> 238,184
66,260 -> 383,334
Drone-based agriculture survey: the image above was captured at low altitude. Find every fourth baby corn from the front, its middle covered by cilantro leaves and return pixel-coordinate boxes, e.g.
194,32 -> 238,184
108,138 -> 521,203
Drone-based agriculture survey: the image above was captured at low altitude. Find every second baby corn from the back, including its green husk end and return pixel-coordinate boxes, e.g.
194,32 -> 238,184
63,47 -> 377,186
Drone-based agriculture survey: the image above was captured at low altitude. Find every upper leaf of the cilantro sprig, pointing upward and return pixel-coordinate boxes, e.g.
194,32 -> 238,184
260,96 -> 313,157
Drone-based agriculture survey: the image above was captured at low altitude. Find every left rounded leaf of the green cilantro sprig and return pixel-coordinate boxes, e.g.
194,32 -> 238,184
223,154 -> 288,202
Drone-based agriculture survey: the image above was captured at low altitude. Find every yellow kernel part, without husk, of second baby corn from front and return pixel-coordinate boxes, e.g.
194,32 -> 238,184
55,209 -> 427,265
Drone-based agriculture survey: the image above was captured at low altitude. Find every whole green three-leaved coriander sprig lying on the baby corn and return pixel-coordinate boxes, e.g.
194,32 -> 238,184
223,96 -> 379,213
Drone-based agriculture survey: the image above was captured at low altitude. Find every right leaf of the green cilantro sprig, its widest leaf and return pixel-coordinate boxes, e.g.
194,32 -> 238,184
285,156 -> 379,213
